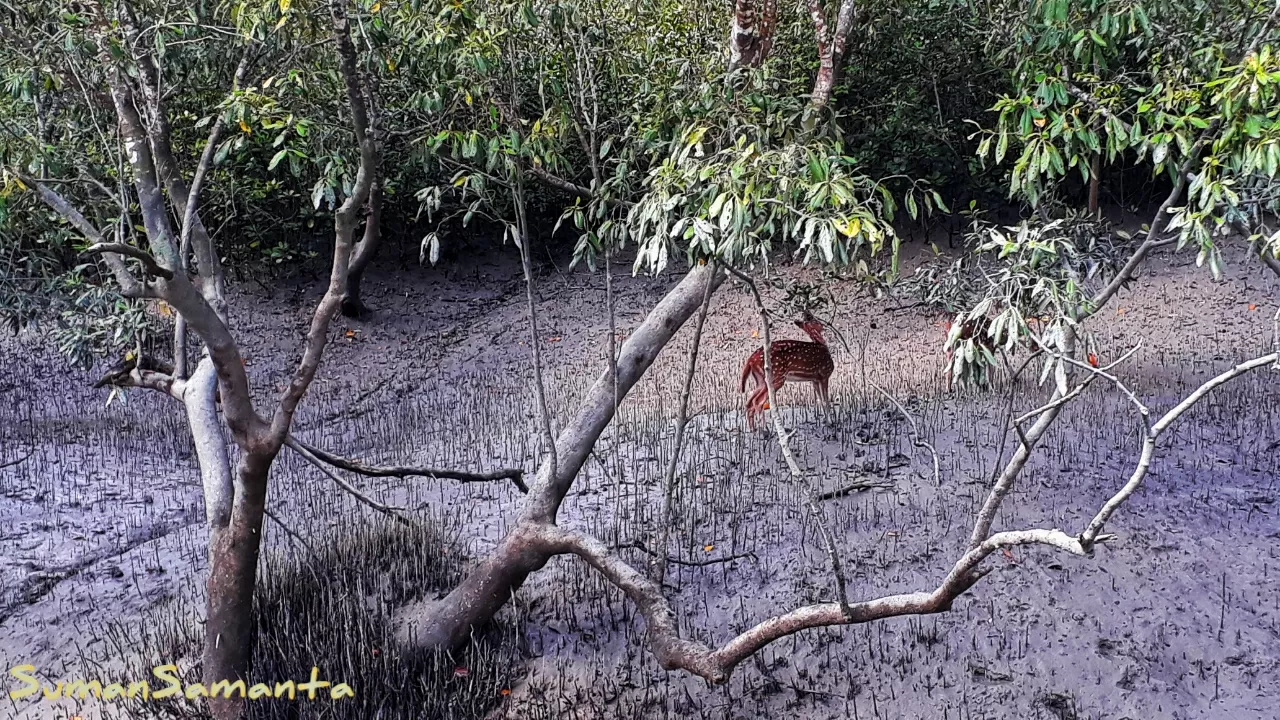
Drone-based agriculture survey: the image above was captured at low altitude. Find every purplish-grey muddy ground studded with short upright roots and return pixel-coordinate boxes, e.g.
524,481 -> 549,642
0,234 -> 1280,720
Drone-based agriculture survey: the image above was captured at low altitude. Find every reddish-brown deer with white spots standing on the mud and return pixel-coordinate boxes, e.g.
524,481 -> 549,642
737,315 -> 836,430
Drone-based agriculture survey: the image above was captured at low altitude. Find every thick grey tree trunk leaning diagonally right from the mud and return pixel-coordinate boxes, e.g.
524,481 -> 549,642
413,265 -> 724,648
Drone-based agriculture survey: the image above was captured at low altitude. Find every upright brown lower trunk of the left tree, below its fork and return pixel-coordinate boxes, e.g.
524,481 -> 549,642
204,452 -> 275,720
